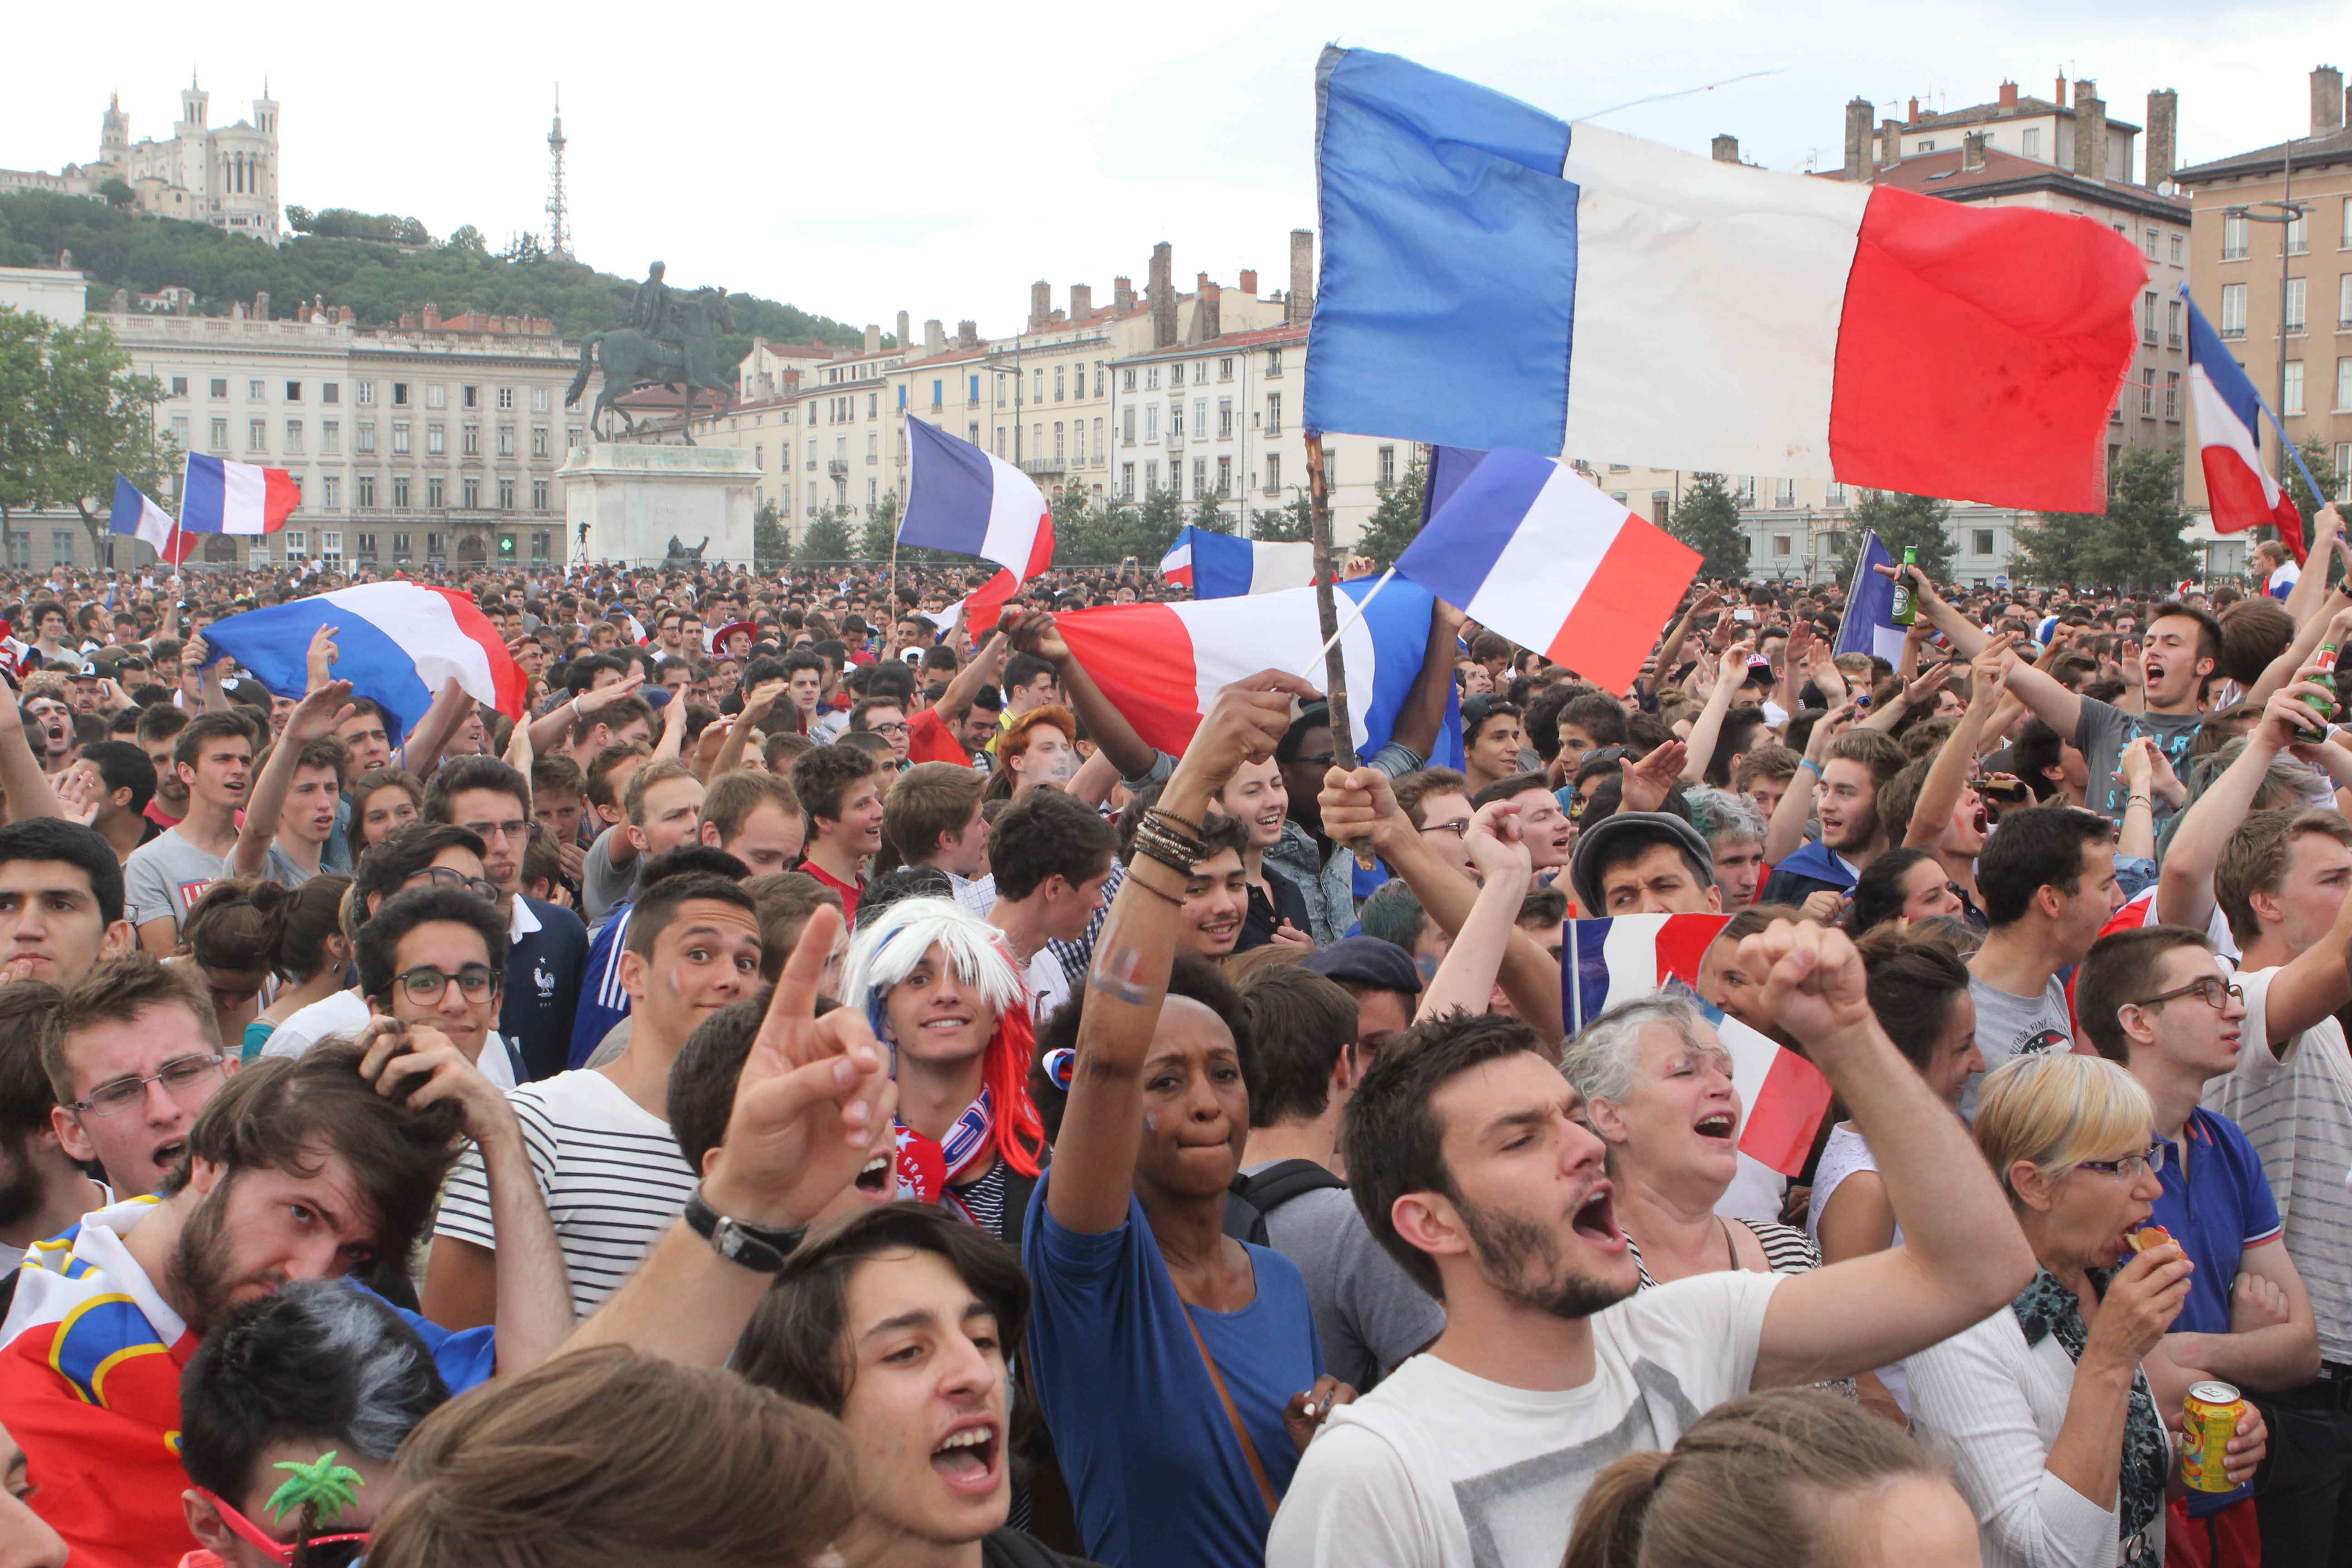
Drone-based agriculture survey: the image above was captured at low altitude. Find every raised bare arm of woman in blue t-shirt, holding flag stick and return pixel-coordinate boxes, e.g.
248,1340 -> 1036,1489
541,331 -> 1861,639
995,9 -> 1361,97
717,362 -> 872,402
1047,670 -> 1313,1234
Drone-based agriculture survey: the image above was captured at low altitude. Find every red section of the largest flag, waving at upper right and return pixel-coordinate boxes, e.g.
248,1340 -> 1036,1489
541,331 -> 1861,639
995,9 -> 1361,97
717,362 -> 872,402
1830,188 -> 2147,513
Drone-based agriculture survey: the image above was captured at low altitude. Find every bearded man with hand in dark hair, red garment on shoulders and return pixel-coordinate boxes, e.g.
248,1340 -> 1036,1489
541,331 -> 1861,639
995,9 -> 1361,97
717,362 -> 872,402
0,957 -> 572,1568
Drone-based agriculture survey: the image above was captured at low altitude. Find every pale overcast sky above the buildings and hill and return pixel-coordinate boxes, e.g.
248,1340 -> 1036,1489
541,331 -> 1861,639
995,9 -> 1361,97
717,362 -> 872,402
0,0 -> 2352,334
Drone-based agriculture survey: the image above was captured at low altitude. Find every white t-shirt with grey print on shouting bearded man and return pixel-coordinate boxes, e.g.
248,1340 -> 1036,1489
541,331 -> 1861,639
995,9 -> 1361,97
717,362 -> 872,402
1265,1269 -> 1780,1568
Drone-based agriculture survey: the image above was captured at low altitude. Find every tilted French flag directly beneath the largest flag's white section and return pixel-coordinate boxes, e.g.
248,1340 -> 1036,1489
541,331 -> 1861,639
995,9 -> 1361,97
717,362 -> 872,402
1397,446 -> 1705,691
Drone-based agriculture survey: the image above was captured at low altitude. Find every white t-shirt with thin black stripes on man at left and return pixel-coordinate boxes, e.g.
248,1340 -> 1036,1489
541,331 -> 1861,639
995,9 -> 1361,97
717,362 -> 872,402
433,1072 -> 694,1317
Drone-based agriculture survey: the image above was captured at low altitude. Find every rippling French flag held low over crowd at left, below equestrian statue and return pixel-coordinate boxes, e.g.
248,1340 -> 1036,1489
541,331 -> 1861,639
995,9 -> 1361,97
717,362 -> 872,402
205,583 -> 527,734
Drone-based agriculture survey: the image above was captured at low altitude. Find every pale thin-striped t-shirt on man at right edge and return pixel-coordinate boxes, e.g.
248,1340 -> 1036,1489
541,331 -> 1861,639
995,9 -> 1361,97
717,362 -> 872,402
2204,969 -> 2352,1366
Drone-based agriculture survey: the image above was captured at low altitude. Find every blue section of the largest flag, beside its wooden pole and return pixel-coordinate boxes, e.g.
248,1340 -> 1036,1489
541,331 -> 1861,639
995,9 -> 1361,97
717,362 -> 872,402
1305,49 -> 1578,451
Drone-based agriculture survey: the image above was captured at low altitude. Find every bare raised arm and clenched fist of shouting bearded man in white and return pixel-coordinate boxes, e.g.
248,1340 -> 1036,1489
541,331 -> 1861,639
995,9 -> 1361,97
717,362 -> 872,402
1738,921 -> 2034,1387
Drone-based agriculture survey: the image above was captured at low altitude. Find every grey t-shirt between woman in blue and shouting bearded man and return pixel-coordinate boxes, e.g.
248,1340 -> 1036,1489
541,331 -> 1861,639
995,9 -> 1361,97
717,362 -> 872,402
1242,1159 -> 1446,1394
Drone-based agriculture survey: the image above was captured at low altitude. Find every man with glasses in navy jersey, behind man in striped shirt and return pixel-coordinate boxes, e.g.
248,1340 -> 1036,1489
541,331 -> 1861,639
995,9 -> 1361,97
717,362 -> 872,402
426,757 -> 588,1079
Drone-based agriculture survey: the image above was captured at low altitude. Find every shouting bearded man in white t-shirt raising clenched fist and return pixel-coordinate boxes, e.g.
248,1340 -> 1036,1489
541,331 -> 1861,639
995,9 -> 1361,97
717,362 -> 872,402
1265,921 -> 2034,1568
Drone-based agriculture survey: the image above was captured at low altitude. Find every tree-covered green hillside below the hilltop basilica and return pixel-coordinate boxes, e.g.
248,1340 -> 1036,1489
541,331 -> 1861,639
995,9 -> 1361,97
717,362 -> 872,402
0,191 -> 863,364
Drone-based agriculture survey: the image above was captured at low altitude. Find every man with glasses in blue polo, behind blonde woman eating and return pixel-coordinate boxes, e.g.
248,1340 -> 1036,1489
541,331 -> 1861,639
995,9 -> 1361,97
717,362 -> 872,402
2074,926 -> 2319,1563
